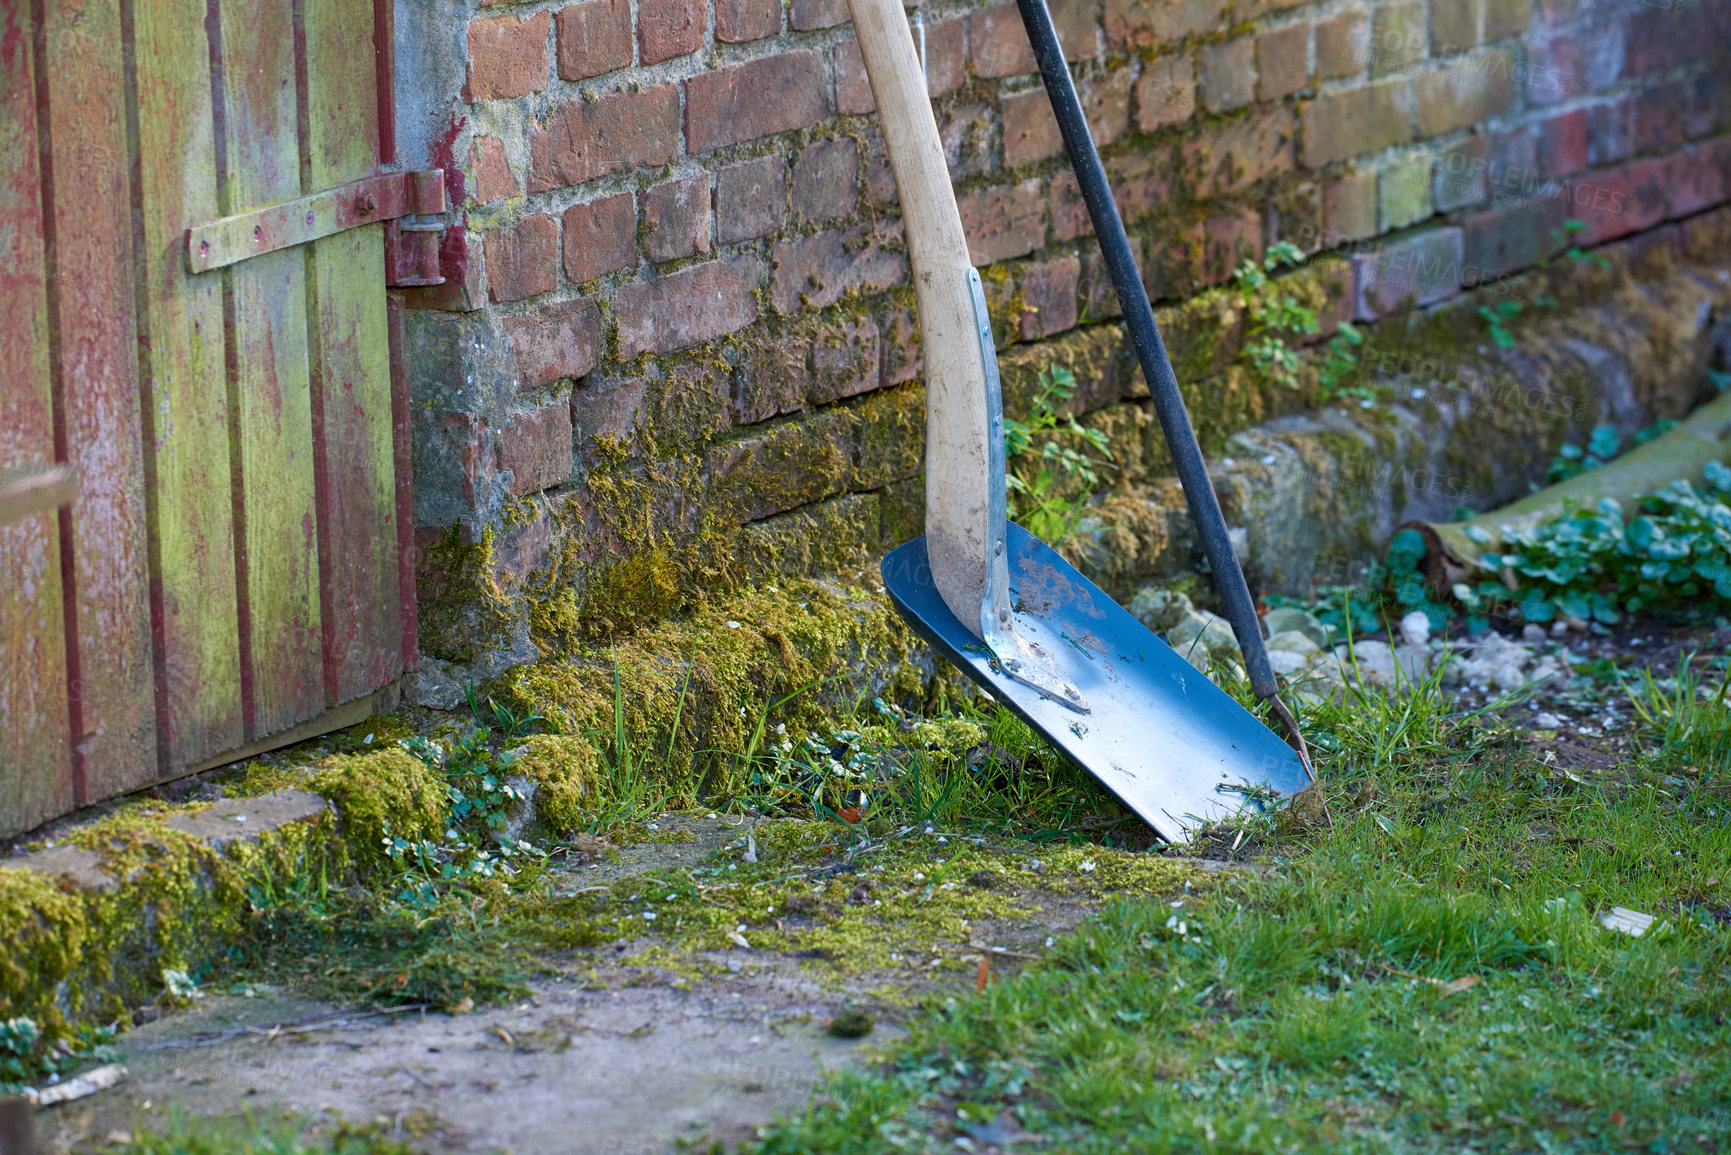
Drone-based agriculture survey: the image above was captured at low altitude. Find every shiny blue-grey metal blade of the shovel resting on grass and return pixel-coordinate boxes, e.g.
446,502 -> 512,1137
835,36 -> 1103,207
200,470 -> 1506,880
883,523 -> 1310,842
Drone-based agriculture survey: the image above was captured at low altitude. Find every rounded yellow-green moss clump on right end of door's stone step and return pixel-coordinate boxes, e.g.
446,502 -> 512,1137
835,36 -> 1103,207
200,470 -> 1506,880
306,746 -> 447,878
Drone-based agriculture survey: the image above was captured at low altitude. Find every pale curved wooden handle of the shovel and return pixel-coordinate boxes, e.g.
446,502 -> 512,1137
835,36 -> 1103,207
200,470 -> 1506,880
848,0 -> 992,636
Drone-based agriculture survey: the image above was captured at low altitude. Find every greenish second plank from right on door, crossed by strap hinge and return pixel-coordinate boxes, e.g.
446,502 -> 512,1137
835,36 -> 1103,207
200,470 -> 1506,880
211,0 -> 325,739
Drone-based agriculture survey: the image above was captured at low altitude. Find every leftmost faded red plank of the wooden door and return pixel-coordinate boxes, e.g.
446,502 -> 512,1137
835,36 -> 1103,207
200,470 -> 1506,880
0,0 -> 73,835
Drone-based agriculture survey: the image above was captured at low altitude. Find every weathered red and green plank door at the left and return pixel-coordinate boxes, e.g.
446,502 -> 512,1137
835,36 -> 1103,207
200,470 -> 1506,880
0,0 -> 425,835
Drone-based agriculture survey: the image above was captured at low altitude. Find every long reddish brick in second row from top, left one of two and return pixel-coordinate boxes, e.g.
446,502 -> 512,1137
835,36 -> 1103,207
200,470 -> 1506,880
528,85 -> 679,192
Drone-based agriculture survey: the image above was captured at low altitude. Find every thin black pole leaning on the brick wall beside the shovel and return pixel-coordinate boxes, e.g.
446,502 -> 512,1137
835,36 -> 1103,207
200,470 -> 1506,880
1016,0 -> 1277,698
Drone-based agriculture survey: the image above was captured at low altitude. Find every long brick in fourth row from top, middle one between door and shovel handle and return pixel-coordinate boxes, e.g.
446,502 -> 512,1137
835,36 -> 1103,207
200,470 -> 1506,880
613,256 -> 763,360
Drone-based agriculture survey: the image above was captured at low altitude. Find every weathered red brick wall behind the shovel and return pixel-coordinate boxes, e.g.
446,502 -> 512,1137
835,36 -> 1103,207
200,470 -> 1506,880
398,0 -> 1731,656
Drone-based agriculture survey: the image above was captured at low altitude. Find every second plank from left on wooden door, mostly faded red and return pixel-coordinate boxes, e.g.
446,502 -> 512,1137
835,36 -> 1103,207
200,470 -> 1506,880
43,0 -> 156,803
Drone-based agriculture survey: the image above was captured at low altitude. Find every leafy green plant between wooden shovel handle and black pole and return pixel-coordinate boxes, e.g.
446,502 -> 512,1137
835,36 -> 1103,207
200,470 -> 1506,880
1004,365 -> 1116,545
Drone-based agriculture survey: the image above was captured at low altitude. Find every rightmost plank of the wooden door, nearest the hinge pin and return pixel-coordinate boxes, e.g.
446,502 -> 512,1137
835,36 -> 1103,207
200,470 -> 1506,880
301,0 -> 403,705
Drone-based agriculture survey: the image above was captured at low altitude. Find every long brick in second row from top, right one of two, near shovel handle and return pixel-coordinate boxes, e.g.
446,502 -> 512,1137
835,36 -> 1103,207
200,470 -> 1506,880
685,50 -> 829,156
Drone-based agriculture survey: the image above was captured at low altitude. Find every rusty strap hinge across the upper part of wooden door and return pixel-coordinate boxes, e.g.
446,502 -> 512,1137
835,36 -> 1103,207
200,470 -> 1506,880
187,168 -> 445,275
